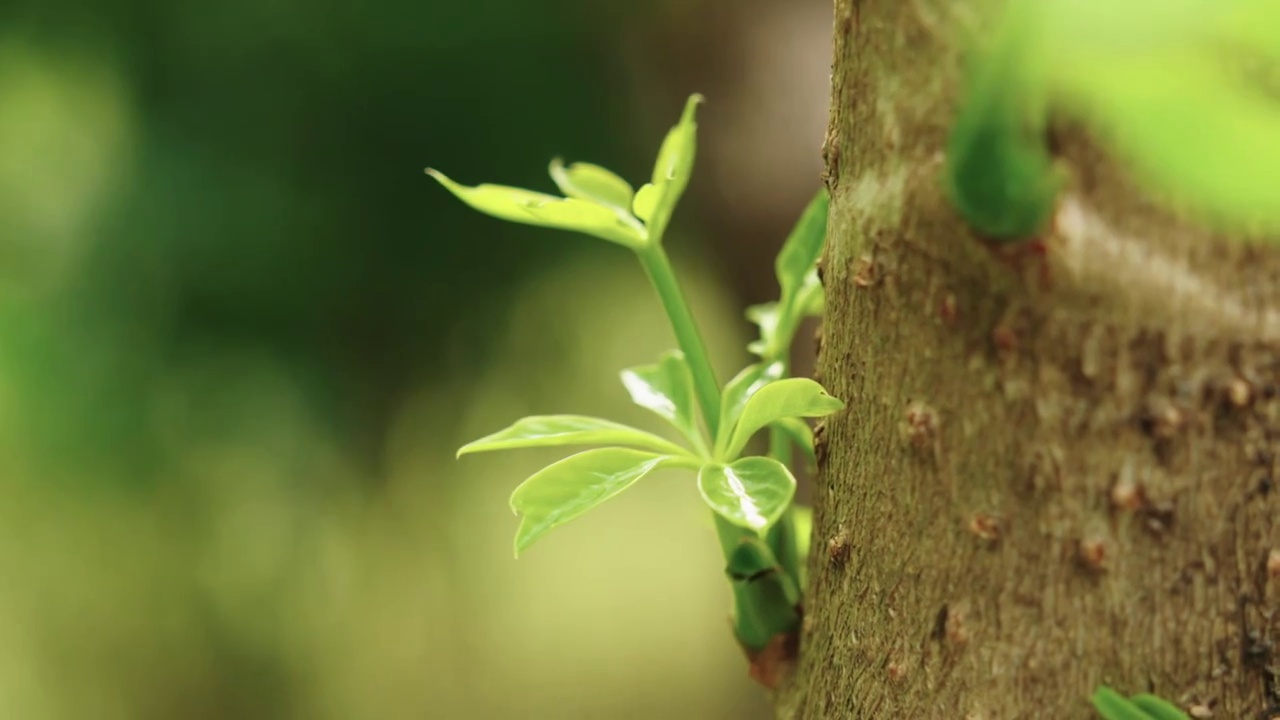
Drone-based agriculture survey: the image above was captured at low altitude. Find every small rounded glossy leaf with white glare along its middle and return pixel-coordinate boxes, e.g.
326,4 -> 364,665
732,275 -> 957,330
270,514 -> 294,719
698,457 -> 796,533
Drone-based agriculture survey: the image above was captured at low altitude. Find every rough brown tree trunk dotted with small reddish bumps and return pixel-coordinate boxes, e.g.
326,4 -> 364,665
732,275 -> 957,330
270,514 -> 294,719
777,0 -> 1280,720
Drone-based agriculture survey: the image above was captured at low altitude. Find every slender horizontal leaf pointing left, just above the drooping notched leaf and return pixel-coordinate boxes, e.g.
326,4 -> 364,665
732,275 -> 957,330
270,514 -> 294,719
457,415 -> 689,457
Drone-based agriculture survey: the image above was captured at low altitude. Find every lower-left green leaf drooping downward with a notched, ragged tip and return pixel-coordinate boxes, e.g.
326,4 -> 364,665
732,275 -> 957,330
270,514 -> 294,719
511,447 -> 680,557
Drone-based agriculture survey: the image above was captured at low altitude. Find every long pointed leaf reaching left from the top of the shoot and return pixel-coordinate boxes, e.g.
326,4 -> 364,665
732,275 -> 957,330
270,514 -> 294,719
426,168 -> 646,247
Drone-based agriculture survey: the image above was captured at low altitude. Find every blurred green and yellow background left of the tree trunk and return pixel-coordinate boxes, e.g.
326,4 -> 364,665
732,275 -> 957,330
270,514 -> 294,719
0,0 -> 831,720
